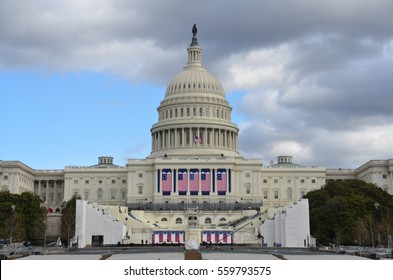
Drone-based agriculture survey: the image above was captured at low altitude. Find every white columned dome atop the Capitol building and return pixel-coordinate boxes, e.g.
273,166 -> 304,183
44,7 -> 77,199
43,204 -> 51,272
151,25 -> 239,157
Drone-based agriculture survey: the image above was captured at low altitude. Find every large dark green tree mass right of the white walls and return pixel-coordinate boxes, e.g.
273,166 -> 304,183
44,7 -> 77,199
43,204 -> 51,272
306,180 -> 393,246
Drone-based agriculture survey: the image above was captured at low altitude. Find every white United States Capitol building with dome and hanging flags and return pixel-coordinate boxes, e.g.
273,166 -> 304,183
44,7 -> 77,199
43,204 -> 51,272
0,27 -> 393,245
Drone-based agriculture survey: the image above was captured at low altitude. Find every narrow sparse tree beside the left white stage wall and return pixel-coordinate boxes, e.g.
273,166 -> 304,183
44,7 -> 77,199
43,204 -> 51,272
61,195 -> 80,247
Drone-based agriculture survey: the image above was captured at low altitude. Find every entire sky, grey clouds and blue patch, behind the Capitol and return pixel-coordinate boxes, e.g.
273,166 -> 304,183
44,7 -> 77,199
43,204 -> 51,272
0,0 -> 393,169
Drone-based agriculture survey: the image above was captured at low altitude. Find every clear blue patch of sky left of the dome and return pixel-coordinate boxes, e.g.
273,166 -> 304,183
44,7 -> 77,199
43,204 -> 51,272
0,70 -> 245,169
